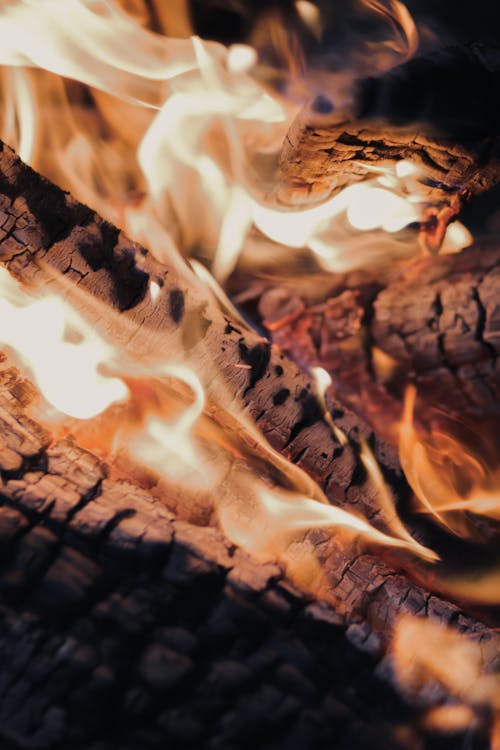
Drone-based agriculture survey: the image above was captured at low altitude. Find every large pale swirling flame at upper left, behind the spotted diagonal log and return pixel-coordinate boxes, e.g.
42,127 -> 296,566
0,0 -> 434,281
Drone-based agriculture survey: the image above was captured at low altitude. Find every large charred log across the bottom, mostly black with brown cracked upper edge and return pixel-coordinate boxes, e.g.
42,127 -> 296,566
0,354 -> 498,750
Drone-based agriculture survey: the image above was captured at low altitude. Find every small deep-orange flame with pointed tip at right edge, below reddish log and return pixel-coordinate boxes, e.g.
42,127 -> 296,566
399,386 -> 500,536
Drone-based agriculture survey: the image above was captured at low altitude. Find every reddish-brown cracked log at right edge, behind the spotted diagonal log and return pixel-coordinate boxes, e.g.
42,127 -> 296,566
260,242 -> 500,444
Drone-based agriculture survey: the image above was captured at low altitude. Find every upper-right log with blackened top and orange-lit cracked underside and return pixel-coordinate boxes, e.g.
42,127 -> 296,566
276,45 -> 500,222
